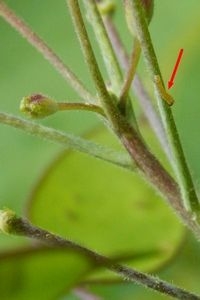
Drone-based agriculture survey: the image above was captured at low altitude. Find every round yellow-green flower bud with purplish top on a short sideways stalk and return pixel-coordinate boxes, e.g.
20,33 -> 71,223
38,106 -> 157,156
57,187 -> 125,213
20,94 -> 58,118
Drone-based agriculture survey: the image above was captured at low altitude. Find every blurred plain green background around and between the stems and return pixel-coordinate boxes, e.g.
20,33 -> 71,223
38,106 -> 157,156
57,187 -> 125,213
0,0 -> 200,300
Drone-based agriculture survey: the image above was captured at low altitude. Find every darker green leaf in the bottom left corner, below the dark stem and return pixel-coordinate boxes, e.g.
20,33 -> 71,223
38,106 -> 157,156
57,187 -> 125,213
0,247 -> 91,300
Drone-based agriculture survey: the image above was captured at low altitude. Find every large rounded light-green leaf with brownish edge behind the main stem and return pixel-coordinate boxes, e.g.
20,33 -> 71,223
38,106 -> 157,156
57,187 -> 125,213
29,127 -> 183,277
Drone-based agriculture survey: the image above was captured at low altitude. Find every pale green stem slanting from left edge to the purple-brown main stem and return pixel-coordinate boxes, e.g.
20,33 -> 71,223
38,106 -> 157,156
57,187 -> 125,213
0,112 -> 131,169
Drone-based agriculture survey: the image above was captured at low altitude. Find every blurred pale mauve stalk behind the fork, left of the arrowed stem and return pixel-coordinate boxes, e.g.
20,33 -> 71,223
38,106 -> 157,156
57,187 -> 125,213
103,15 -> 171,161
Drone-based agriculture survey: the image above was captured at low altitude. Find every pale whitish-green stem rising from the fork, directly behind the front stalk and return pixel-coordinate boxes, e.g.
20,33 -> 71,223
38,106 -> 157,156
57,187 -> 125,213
83,0 -> 122,96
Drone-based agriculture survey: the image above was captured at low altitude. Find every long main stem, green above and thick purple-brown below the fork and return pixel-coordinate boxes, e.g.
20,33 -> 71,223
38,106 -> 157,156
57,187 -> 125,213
67,0 -> 200,237
